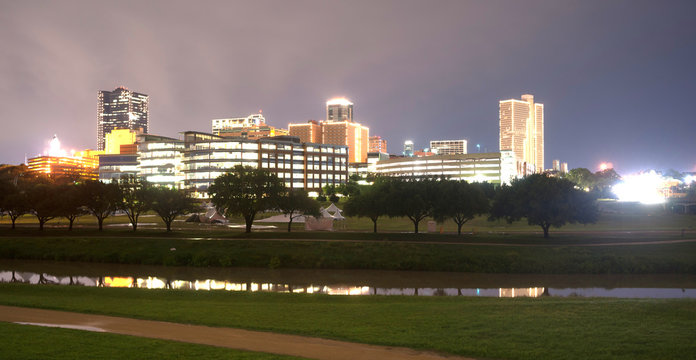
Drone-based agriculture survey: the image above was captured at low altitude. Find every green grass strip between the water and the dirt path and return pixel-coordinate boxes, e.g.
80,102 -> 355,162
0,284 -> 696,359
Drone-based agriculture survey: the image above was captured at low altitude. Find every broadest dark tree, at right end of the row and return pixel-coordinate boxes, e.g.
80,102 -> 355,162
490,174 -> 597,238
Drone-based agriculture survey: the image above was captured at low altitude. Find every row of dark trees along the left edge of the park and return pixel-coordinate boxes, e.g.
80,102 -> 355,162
0,174 -> 200,231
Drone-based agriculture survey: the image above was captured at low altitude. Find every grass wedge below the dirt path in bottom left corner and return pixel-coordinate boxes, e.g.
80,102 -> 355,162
0,322 -> 299,360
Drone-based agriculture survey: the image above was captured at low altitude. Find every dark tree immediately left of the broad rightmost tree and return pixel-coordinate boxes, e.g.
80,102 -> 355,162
433,180 -> 489,235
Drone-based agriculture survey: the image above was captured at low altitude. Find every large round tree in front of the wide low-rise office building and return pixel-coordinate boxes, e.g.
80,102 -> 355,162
208,165 -> 285,233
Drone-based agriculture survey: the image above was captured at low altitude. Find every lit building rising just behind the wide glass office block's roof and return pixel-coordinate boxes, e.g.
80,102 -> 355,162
212,114 -> 289,140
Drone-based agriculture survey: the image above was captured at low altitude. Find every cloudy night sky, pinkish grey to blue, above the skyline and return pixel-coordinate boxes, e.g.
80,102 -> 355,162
0,0 -> 696,174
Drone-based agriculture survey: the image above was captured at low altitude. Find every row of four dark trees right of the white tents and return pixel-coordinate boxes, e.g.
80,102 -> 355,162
344,174 -> 597,237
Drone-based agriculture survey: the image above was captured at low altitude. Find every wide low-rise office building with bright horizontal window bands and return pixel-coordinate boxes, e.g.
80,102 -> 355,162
138,131 -> 348,197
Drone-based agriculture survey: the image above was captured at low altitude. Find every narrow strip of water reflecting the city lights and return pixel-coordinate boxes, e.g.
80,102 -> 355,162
0,270 -> 696,298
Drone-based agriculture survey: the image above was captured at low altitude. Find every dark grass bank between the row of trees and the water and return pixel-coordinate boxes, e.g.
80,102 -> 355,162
0,232 -> 696,274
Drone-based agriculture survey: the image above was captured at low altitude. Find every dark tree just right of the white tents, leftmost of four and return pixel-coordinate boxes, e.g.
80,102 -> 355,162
344,178 -> 390,233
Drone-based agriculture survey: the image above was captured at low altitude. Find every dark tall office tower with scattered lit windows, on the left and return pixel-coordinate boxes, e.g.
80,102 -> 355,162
97,86 -> 150,150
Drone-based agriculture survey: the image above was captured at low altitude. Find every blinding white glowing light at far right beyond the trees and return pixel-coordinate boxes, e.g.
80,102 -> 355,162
612,170 -> 665,204
